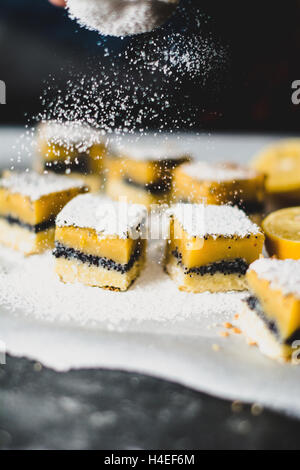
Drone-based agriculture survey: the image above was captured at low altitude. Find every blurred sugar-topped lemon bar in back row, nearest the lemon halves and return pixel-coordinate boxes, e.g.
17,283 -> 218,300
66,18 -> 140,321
172,162 -> 265,212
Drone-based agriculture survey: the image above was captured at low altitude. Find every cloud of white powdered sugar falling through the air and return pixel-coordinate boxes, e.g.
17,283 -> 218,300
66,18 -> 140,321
37,4 -> 229,135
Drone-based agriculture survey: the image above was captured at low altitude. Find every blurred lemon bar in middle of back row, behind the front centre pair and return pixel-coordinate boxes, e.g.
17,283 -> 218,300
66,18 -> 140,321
106,137 -> 190,209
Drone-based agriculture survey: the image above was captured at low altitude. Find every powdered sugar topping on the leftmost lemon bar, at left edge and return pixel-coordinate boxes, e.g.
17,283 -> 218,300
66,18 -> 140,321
0,171 -> 85,201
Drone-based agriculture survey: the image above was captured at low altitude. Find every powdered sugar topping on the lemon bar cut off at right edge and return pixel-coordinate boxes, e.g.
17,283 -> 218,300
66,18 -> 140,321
249,258 -> 300,299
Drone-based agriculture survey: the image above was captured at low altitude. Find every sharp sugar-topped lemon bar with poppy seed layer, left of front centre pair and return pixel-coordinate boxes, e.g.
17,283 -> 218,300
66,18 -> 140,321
53,194 -> 147,291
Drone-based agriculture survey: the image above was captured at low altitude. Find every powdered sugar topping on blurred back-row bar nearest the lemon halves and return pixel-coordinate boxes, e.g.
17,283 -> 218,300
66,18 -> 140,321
181,161 -> 257,182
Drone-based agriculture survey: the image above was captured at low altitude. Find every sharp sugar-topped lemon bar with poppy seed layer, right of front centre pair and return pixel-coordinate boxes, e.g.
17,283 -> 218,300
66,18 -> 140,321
165,203 -> 264,293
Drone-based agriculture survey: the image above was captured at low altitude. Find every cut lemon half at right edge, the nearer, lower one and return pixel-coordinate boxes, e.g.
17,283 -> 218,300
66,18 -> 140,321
262,207 -> 300,259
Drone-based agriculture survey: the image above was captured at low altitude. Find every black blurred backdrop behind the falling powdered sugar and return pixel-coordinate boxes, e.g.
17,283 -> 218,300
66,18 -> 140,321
0,0 -> 300,132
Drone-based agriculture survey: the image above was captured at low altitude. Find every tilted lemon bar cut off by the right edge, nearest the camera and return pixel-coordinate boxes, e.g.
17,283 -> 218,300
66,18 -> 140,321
238,258 -> 300,360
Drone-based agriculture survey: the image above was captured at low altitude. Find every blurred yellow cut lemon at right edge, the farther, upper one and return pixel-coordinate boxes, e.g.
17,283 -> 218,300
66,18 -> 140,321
251,139 -> 300,201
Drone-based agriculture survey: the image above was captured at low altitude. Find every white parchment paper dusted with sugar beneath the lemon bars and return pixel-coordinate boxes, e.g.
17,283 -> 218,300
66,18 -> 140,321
0,131 -> 300,416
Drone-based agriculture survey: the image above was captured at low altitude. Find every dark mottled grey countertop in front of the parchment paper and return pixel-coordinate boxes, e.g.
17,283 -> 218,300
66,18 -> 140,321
0,356 -> 300,450
